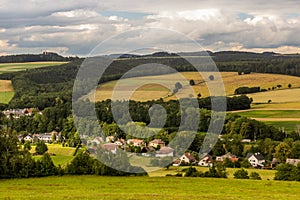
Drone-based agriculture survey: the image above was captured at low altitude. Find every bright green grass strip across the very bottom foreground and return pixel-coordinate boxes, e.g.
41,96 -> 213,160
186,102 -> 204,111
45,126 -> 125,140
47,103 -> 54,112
0,176 -> 300,200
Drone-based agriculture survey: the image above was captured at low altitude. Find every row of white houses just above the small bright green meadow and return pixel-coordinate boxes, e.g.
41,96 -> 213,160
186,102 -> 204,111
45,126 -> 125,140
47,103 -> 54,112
18,131 -> 60,143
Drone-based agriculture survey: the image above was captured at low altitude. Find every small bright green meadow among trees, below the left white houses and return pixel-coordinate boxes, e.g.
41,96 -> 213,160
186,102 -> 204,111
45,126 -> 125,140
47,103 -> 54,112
30,144 -> 75,166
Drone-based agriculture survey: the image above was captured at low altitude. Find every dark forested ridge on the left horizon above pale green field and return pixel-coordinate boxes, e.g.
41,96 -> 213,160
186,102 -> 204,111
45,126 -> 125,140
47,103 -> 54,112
0,52 -> 74,63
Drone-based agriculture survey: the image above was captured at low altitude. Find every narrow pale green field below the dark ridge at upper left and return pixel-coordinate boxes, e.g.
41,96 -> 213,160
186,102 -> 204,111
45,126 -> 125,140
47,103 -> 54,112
0,62 -> 67,74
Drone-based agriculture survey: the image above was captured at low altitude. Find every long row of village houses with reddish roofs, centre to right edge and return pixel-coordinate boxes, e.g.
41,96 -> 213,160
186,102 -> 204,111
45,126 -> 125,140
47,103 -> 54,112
89,136 -> 300,168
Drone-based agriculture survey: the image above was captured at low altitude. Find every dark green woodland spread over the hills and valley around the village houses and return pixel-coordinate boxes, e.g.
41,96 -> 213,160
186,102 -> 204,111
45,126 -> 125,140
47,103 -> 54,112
0,52 -> 300,178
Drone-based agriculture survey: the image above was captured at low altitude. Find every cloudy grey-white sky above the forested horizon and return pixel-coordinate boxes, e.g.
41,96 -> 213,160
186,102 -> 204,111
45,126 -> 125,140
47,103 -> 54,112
0,0 -> 300,56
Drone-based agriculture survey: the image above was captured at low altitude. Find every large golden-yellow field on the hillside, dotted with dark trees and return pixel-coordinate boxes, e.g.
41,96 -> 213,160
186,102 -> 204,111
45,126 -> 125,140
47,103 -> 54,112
90,72 -> 300,103
